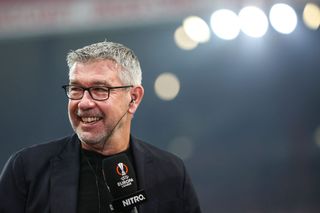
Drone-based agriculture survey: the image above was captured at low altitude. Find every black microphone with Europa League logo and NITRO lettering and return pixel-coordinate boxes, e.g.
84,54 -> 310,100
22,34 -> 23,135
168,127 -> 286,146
102,153 -> 147,213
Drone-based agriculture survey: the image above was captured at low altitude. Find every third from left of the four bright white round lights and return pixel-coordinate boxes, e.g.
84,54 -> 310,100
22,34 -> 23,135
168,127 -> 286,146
239,6 -> 269,38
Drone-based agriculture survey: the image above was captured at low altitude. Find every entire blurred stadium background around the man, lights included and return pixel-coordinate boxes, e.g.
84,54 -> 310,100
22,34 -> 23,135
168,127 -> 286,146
0,0 -> 320,213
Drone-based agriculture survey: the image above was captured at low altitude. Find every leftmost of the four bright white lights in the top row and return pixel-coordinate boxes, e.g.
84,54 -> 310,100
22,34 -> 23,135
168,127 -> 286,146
182,16 -> 210,43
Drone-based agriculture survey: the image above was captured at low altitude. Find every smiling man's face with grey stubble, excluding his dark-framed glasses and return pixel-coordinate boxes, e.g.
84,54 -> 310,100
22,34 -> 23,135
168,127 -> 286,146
68,60 -> 131,145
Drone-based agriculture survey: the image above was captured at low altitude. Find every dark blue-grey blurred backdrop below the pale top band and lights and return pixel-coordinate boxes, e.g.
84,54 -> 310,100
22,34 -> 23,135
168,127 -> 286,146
0,15 -> 320,213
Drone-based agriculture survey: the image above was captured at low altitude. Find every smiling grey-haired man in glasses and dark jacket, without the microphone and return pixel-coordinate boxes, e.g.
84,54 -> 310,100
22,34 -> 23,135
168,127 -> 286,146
0,42 -> 200,213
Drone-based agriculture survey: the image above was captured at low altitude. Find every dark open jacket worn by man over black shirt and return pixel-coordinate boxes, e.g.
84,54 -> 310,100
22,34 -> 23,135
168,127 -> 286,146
0,135 -> 201,213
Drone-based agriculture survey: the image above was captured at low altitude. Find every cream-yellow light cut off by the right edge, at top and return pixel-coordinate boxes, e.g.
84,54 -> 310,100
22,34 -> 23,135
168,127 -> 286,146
303,3 -> 320,30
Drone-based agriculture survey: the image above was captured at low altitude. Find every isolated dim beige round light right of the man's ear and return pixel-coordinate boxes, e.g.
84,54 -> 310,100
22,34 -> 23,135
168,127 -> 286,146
154,73 -> 180,101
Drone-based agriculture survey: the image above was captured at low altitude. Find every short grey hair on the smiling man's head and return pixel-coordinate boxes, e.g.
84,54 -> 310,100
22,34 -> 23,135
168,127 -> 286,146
67,41 -> 142,85
